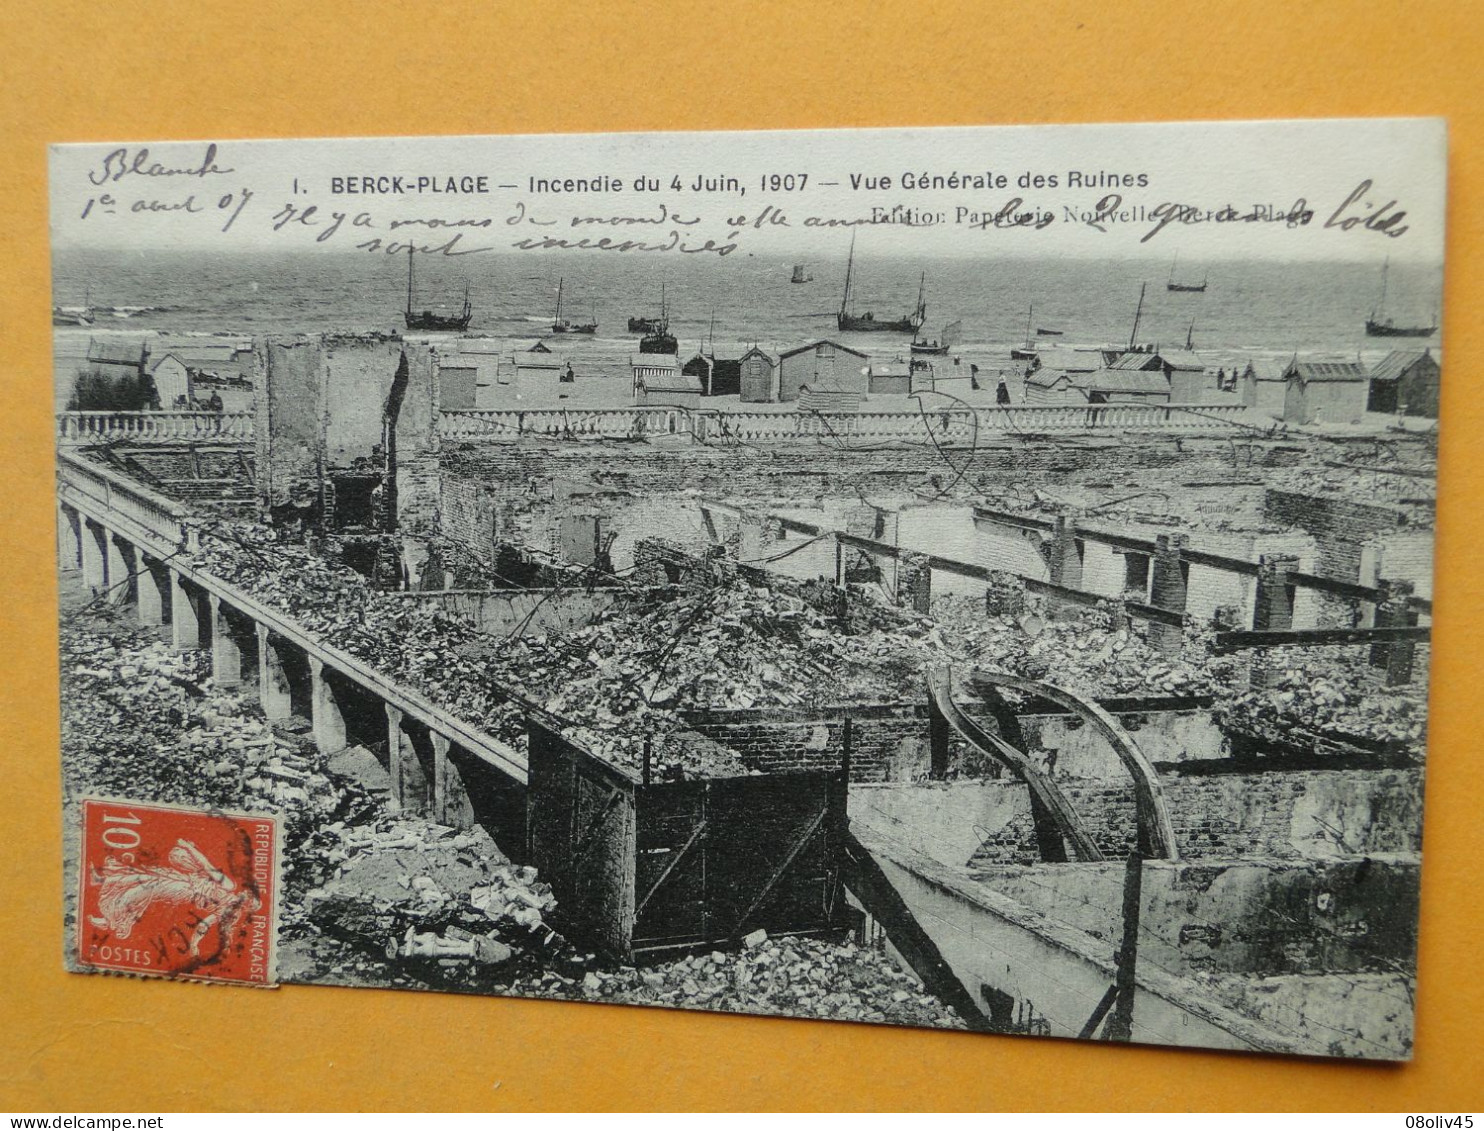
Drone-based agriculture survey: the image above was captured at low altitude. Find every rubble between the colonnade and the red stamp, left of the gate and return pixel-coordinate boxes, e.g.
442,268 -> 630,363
61,593 -> 561,972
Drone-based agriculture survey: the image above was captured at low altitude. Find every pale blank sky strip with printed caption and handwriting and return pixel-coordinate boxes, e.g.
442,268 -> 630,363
50,119 -> 1447,264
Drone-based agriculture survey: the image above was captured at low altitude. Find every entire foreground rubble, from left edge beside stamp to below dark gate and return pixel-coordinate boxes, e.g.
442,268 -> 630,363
61,575 -> 979,1027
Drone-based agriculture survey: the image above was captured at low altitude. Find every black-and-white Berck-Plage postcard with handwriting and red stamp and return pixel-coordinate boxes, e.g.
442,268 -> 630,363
50,120 -> 1447,1060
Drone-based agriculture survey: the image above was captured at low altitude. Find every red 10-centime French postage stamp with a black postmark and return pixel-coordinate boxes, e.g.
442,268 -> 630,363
77,799 -> 279,986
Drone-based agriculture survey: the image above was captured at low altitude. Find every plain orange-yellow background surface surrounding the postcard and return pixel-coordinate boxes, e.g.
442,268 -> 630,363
0,0 -> 1484,1112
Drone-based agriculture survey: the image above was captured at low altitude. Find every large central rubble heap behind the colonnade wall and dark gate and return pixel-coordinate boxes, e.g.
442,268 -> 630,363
192,525 -> 899,776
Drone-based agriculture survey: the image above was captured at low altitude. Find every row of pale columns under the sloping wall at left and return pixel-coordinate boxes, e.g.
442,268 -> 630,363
58,505 -> 475,828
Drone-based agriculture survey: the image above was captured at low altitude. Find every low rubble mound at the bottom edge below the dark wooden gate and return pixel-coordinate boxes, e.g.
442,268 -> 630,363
509,931 -> 965,1029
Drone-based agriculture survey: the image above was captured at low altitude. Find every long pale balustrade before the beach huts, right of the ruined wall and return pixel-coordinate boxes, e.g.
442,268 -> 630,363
438,404 -> 1247,444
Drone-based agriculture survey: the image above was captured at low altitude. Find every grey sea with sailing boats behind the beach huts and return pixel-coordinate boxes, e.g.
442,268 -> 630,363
52,248 -> 1442,407
